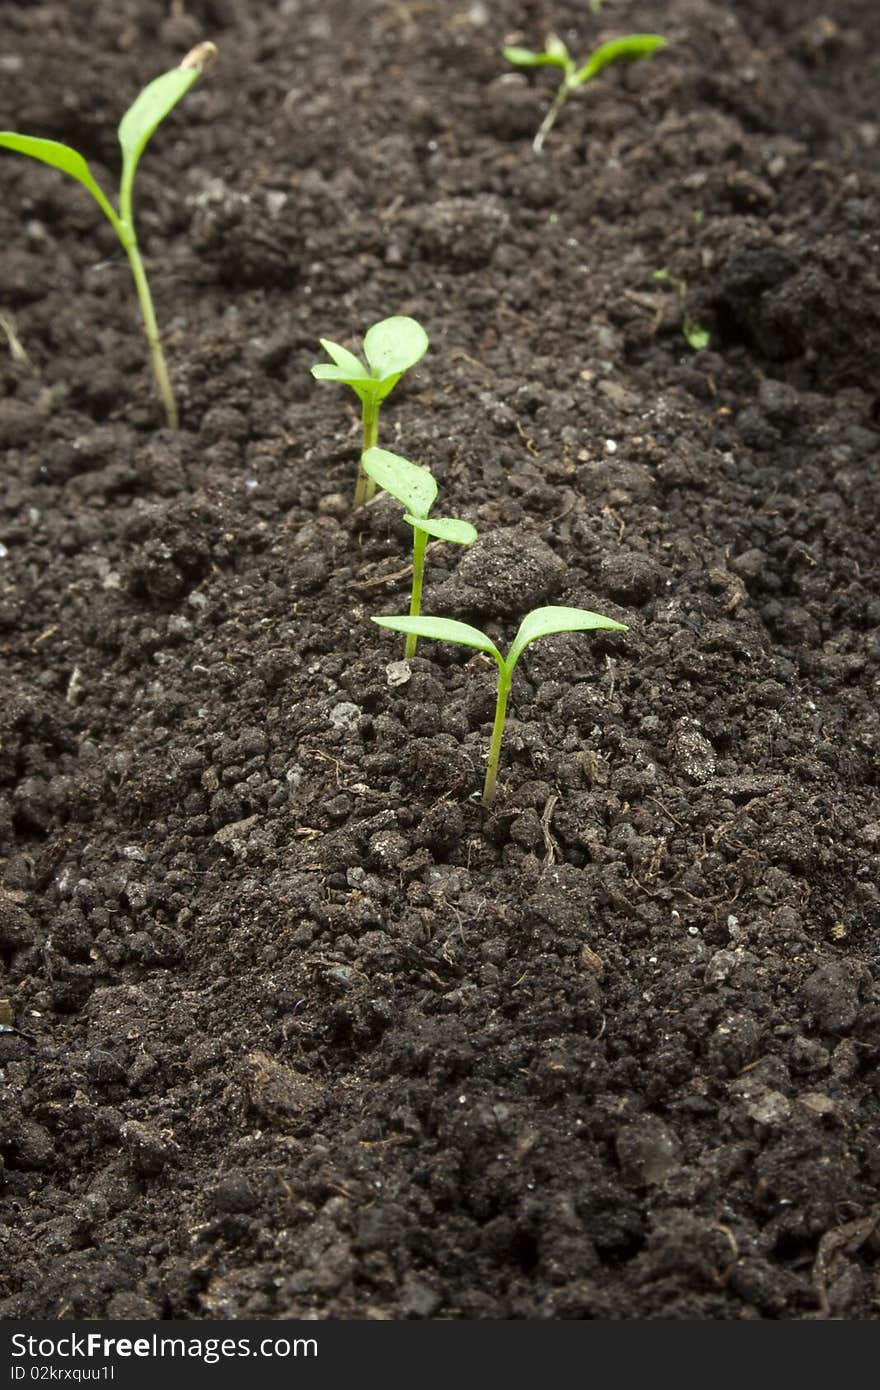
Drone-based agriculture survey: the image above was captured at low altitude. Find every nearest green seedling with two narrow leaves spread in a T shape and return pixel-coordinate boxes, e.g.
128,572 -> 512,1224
373,606 -> 627,806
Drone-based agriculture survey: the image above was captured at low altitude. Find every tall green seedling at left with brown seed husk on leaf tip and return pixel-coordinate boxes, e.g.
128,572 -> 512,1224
0,43 -> 217,430
